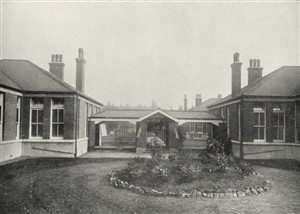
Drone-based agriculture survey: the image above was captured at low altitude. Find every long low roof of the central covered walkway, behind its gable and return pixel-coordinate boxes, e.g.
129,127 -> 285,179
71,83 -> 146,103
92,110 -> 221,120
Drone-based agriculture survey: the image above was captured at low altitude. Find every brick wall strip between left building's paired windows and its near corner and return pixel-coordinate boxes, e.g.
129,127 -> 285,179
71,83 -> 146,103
64,97 -> 76,140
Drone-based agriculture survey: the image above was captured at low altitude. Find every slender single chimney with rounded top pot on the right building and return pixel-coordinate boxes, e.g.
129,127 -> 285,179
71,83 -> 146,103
231,53 -> 242,96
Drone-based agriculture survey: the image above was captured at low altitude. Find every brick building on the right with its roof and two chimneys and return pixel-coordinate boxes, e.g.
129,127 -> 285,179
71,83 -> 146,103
208,53 -> 300,160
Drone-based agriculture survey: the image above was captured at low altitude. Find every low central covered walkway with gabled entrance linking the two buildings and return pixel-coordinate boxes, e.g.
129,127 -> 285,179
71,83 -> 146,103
90,109 -> 223,153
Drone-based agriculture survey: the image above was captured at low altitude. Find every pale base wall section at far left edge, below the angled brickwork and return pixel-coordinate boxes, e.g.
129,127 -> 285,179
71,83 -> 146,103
0,140 -> 22,162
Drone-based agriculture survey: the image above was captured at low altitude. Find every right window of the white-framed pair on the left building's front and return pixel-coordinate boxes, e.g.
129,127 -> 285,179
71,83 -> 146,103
52,98 -> 64,138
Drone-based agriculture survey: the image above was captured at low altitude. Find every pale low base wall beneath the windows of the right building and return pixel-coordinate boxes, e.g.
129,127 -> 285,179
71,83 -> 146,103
232,141 -> 300,161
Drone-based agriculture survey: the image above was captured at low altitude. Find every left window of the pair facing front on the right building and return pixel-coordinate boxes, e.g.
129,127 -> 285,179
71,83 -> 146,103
253,103 -> 266,140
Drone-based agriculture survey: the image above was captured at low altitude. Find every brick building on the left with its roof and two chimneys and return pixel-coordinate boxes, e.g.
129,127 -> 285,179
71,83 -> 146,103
0,48 -> 103,161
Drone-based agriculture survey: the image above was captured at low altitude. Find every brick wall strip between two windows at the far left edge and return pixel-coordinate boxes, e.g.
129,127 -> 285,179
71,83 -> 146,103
3,93 -> 18,141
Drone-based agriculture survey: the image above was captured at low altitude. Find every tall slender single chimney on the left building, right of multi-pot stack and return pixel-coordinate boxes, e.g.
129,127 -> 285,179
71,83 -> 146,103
76,48 -> 86,93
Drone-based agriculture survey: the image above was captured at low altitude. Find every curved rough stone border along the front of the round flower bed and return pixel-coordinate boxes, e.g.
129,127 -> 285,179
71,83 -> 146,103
109,171 -> 272,198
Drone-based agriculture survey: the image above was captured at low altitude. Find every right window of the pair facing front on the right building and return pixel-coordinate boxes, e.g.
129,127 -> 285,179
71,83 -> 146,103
272,104 -> 285,141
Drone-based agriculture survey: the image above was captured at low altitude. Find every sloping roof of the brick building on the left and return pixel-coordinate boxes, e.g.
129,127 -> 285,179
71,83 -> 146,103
0,59 -> 103,106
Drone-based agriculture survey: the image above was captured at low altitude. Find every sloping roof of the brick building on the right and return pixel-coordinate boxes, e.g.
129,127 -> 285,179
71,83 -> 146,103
208,66 -> 300,107
